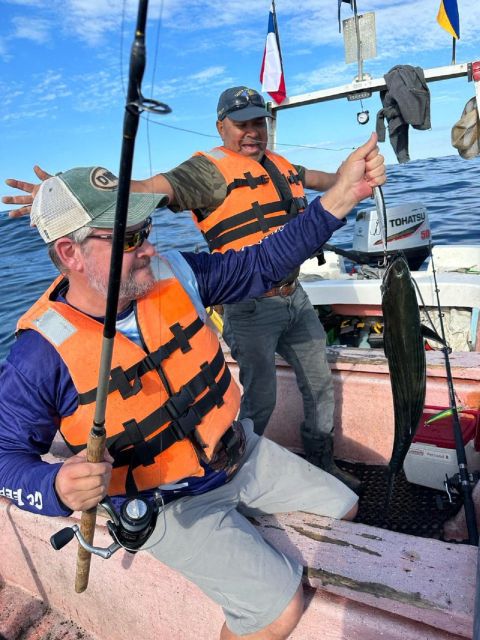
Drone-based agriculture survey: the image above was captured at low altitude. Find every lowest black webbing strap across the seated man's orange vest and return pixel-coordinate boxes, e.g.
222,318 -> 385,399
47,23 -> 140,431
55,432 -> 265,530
109,367 -> 231,468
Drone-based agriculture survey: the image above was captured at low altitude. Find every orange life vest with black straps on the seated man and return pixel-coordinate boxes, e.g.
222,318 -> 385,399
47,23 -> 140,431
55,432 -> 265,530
17,278 -> 240,495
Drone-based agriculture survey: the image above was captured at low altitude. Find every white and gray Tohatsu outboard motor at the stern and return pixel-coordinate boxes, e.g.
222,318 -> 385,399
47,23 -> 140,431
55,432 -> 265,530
352,202 -> 430,271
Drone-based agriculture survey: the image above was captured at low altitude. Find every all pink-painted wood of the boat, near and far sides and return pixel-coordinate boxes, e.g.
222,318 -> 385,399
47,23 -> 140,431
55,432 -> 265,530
0,349 -> 480,640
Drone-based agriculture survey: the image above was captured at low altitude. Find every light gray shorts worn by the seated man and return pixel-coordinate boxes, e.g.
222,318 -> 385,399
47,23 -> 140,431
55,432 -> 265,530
145,420 -> 357,635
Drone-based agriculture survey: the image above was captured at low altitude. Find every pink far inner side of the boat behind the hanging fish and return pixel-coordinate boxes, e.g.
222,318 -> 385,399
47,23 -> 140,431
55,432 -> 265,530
251,347 -> 480,464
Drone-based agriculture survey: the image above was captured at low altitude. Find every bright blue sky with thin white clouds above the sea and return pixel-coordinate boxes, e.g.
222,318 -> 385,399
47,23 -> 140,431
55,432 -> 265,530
0,0 -> 480,193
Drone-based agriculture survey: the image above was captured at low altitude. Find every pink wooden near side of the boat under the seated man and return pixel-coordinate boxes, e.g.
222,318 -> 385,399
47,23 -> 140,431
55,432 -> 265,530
0,498 -> 477,640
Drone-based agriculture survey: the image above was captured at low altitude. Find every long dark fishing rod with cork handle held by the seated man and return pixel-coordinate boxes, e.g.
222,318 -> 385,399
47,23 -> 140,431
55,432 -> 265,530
75,0 -> 171,593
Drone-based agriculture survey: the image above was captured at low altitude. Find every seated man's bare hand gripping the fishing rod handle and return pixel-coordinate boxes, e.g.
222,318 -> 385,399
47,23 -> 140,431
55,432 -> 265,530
55,450 -> 113,511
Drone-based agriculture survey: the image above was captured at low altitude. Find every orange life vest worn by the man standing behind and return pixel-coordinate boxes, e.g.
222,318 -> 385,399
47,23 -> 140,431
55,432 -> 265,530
194,147 -> 307,253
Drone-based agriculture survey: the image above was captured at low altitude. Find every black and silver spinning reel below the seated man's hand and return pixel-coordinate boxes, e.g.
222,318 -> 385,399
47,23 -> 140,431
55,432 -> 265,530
50,496 -> 159,560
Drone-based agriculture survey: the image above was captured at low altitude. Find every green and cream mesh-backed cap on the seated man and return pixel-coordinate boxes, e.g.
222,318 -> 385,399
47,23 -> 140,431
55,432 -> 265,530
30,167 -> 168,243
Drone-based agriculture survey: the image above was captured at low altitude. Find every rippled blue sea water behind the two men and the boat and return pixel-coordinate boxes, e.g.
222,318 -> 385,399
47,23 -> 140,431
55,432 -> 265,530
0,156 -> 480,359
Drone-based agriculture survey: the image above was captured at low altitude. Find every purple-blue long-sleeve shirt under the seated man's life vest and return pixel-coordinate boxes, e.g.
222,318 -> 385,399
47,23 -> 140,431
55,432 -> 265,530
0,198 -> 343,516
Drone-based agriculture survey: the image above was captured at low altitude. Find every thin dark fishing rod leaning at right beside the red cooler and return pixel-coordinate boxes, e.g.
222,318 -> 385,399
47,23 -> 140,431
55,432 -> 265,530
430,243 -> 479,546
